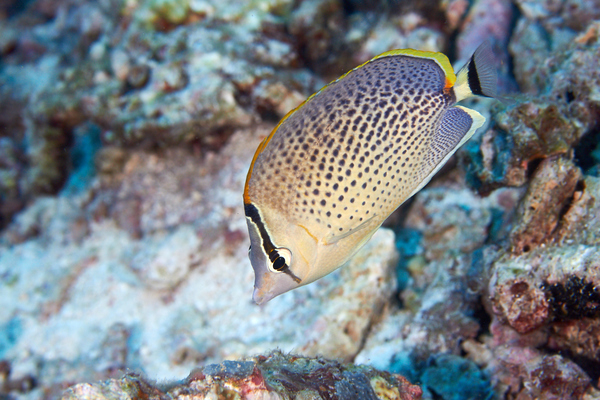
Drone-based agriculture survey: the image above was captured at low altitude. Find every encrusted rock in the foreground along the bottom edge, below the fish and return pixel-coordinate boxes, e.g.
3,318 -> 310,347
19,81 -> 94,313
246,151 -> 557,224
63,352 -> 421,400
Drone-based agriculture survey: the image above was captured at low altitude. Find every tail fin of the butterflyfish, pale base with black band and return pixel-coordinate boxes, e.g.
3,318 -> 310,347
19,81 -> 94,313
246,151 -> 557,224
454,40 -> 498,101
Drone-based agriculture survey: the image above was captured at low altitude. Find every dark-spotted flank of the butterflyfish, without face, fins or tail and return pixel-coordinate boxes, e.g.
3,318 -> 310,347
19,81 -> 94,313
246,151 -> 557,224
249,56 -> 470,238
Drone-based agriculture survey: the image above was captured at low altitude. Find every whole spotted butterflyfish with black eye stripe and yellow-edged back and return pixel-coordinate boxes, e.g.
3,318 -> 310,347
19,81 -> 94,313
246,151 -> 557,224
244,42 -> 496,304
